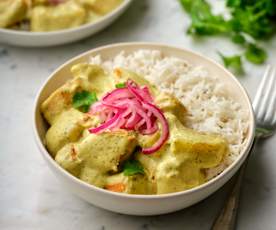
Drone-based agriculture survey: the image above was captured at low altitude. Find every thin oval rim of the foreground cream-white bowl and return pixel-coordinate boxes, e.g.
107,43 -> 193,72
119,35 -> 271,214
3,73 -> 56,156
32,42 -> 255,199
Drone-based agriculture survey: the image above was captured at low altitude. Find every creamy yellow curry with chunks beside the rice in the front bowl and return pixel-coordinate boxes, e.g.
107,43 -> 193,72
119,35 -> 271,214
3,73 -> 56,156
41,63 -> 228,194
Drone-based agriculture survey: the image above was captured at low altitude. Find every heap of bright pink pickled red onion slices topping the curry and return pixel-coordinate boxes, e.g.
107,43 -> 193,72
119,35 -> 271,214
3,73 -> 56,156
89,80 -> 169,154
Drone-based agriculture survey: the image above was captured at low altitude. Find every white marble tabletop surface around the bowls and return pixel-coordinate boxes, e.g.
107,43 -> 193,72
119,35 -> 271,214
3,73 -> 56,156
0,0 -> 276,230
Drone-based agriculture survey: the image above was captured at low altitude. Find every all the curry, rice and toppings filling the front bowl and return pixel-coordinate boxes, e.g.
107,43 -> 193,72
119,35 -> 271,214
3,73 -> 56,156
41,50 -> 247,194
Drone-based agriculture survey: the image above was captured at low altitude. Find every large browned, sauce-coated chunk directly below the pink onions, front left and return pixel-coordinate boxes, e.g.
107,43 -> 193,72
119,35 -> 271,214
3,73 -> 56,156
55,130 -> 137,188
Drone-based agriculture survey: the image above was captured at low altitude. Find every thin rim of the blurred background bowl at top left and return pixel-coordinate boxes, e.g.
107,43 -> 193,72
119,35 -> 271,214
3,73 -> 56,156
0,0 -> 133,37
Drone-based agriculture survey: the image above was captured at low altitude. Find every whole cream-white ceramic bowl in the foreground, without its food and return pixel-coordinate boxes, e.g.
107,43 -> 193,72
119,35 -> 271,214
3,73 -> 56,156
33,43 -> 255,215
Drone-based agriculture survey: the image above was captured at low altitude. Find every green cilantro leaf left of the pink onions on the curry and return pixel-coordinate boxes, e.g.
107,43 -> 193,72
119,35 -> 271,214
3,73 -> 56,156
73,90 -> 98,113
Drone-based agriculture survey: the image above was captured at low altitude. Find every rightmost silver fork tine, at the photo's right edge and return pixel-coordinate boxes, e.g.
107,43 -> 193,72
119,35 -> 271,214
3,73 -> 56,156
264,68 -> 276,125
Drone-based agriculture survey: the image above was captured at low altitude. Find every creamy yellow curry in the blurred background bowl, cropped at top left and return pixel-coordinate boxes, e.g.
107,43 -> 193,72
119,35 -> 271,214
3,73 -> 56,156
0,0 -> 123,32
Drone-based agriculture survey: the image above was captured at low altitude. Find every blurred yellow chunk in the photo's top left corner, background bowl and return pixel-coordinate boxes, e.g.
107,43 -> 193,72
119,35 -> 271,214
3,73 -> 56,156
0,0 -> 28,28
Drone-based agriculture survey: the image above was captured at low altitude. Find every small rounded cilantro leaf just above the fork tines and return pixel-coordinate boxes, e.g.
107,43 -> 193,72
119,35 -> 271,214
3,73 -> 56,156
245,44 -> 267,64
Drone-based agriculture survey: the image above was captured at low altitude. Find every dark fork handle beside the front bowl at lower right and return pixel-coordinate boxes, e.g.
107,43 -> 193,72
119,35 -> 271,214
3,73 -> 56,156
211,139 -> 256,230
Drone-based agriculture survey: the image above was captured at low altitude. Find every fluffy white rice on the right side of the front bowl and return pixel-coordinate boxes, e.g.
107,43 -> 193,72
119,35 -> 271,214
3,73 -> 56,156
91,50 -> 248,179
